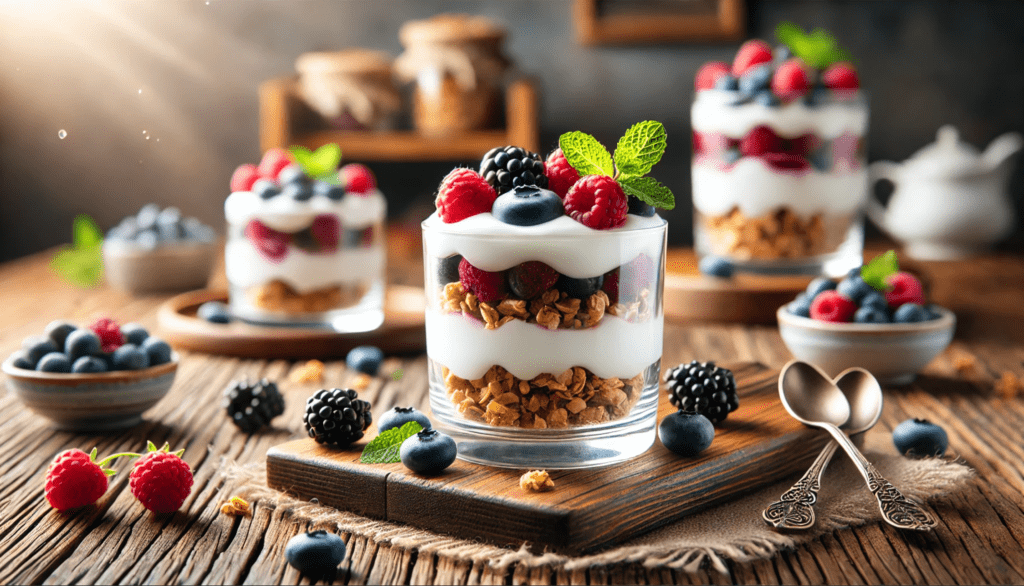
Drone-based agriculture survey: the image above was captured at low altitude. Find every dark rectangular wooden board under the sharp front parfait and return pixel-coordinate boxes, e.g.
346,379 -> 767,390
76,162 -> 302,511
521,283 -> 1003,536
266,364 -> 827,553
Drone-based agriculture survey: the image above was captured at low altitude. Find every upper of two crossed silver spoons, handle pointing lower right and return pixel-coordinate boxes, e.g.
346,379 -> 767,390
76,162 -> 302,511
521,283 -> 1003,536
778,361 -> 935,531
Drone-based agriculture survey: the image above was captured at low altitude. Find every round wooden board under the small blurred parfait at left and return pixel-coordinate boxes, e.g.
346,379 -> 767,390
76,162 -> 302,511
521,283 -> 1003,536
157,285 -> 427,359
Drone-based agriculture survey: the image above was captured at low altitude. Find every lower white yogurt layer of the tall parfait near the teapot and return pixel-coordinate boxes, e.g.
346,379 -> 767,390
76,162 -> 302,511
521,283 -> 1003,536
692,157 -> 867,217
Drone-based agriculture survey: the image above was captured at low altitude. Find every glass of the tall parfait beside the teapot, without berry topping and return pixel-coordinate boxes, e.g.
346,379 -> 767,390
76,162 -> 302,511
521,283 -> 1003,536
690,89 -> 867,277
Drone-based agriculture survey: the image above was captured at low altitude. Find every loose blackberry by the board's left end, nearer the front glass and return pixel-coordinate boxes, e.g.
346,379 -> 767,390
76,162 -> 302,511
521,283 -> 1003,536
302,388 -> 373,448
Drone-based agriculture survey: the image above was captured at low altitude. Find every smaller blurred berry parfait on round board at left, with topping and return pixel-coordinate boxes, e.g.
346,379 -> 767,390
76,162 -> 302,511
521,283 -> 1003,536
224,150 -> 387,332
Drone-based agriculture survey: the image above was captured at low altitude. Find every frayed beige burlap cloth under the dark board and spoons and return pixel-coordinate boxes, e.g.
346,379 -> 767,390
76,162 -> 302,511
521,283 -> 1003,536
224,432 -> 974,573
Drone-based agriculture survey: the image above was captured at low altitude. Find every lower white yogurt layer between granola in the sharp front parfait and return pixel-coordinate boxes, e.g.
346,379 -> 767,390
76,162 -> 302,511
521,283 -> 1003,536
426,308 -> 664,379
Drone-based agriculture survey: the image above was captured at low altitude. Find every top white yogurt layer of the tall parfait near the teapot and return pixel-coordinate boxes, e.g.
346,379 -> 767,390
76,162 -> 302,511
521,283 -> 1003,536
690,89 -> 867,140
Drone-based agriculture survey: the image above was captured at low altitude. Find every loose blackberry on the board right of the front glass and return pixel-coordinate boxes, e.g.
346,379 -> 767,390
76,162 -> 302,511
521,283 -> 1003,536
665,361 -> 739,425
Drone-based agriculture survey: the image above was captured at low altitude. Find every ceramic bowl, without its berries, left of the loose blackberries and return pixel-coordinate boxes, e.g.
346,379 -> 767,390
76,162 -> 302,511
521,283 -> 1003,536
2,355 -> 178,431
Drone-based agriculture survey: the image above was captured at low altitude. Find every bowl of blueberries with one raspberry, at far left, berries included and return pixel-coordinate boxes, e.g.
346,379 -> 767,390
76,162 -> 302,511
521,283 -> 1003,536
2,319 -> 178,431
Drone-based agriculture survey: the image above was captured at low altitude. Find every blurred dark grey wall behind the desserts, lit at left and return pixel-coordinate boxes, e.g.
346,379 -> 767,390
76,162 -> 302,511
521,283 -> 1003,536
0,0 -> 1024,260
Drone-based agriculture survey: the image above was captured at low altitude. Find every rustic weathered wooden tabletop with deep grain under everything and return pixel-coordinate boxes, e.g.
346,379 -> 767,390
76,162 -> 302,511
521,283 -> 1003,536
0,231 -> 1024,584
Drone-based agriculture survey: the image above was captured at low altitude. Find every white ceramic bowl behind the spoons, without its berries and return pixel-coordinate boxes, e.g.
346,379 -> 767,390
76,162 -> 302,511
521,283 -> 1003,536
775,305 -> 956,384
